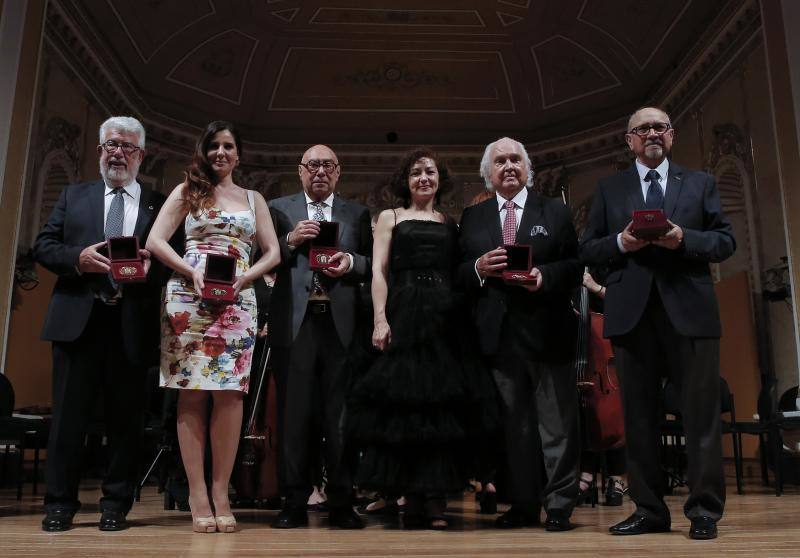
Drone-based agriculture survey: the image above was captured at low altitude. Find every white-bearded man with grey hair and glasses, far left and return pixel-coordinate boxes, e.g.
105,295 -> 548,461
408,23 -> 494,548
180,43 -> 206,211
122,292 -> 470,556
34,117 -> 164,531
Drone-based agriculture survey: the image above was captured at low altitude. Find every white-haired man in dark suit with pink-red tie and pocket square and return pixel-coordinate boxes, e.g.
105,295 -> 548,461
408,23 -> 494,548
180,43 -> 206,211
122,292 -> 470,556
458,138 -> 582,531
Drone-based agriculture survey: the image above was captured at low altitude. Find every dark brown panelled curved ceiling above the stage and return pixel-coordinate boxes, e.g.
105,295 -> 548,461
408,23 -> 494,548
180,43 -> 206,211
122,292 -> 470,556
54,0 -> 731,145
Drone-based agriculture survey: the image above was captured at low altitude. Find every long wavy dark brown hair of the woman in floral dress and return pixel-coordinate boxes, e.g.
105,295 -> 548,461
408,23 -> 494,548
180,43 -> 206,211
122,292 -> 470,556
183,120 -> 242,215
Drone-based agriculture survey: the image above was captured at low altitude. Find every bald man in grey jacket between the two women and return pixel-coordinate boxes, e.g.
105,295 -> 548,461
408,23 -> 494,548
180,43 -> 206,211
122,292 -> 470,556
269,145 -> 372,529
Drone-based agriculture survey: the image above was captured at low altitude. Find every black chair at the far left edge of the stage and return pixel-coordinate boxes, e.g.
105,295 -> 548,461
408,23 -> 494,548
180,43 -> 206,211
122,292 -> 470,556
0,374 -> 50,500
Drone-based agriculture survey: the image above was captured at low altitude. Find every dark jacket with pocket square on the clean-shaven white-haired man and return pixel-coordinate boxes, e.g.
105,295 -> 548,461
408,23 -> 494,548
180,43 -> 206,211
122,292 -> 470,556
458,190 -> 582,360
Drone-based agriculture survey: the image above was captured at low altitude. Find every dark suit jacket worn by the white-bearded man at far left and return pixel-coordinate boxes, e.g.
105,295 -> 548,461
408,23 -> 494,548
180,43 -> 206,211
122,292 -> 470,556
33,180 -> 165,363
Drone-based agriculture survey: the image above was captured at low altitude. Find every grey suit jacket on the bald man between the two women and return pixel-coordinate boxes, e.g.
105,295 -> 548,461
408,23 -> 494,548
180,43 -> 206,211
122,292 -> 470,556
269,191 -> 372,347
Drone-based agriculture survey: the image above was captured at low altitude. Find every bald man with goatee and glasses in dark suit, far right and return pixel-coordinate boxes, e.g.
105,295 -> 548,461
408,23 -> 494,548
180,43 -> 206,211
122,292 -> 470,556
581,107 -> 736,539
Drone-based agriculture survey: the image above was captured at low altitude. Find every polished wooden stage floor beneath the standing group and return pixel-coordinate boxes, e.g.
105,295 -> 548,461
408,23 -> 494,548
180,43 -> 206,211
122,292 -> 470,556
0,479 -> 800,558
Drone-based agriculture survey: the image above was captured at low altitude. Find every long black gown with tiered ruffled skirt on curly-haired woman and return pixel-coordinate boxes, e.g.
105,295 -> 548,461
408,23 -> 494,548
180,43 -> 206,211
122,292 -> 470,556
348,220 -> 497,496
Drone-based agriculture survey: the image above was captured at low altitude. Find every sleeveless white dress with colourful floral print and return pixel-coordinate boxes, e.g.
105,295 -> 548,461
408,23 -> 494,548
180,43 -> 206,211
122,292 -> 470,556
161,191 -> 256,392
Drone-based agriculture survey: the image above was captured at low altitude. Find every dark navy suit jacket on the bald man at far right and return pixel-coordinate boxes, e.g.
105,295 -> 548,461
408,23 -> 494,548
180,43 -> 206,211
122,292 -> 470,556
580,161 -> 736,337
